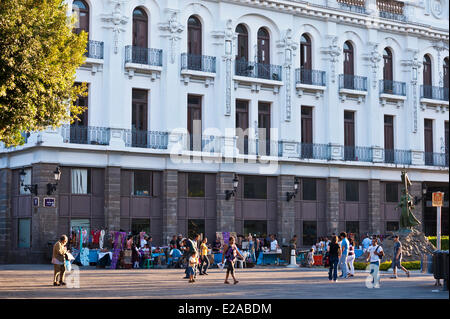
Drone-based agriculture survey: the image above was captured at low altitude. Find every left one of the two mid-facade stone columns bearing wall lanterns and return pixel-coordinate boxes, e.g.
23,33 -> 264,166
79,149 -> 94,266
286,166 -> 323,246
216,172 -> 236,232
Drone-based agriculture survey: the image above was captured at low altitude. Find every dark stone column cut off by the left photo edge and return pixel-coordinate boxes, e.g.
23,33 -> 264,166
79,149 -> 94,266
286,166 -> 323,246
0,168 -> 12,264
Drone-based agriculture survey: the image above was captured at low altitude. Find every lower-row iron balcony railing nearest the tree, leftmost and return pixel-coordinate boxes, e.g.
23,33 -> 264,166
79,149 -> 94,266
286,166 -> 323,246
60,124 -> 110,145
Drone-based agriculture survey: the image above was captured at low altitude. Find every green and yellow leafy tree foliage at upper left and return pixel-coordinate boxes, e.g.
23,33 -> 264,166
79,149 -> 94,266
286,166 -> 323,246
0,0 -> 87,146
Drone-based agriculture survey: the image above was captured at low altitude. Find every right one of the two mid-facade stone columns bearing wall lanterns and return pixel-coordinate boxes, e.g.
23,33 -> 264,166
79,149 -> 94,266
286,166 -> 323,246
277,175 -> 295,245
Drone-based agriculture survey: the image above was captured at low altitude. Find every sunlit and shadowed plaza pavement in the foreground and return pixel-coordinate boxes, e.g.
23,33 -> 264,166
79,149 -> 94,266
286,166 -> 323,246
0,265 -> 449,299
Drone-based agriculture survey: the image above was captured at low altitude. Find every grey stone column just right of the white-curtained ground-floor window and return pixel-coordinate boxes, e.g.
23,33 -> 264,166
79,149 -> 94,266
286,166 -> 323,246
105,166 -> 120,231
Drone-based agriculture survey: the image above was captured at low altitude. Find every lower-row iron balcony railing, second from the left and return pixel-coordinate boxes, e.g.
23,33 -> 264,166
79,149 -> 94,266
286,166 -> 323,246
123,129 -> 169,150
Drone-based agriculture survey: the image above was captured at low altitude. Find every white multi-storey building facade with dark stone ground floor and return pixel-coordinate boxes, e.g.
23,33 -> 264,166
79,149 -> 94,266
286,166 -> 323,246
0,0 -> 449,262
